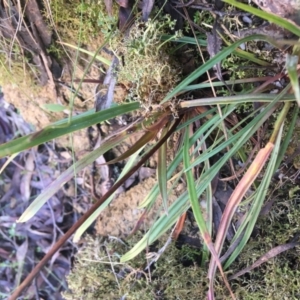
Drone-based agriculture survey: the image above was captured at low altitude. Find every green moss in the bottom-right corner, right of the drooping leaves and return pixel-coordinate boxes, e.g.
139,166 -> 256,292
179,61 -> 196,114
232,196 -> 300,300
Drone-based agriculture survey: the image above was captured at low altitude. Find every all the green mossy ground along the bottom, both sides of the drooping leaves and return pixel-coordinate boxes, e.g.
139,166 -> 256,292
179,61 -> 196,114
64,195 -> 300,300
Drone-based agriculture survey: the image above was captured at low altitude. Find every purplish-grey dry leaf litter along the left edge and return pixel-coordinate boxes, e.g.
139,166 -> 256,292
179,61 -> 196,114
0,94 -> 79,299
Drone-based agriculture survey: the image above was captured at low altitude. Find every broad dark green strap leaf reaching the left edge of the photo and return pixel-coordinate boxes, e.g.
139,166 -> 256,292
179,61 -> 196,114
0,102 -> 139,158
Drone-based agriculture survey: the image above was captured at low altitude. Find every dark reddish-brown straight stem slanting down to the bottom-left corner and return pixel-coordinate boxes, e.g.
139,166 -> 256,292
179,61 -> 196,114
8,116 -> 183,300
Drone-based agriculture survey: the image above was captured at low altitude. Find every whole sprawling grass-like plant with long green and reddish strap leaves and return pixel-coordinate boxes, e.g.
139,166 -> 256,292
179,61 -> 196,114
4,0 -> 300,299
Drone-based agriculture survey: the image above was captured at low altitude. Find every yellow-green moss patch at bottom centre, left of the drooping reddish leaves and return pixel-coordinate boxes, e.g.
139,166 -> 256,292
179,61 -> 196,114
64,237 -> 214,300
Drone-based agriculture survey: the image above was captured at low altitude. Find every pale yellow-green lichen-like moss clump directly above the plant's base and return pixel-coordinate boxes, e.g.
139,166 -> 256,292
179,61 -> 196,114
118,15 -> 180,106
